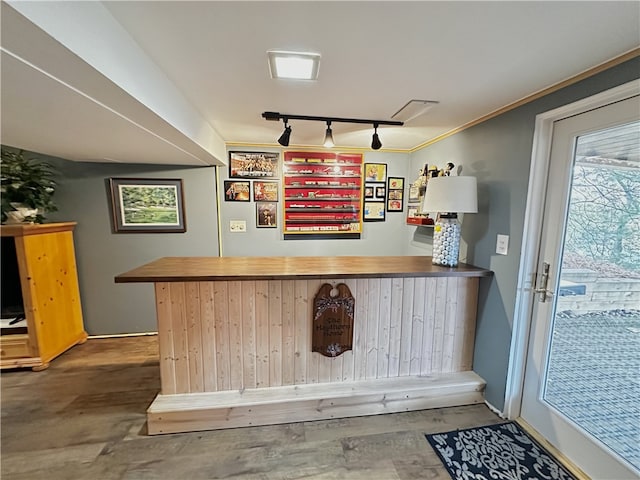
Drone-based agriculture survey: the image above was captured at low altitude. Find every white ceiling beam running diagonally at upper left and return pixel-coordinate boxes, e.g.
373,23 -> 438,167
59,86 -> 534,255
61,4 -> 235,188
2,1 -> 227,165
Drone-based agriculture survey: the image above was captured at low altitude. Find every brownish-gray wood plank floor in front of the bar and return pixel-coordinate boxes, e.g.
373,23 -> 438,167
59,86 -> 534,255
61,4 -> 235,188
0,336 -> 501,480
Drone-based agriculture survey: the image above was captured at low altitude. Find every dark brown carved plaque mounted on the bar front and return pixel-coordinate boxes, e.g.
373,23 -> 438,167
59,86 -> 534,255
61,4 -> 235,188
311,283 -> 355,357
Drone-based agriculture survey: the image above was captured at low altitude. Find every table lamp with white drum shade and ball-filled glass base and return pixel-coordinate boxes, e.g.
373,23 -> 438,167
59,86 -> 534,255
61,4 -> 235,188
422,177 -> 478,267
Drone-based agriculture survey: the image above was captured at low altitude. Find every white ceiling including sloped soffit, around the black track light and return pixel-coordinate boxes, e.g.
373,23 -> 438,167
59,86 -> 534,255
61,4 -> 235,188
1,1 -> 640,165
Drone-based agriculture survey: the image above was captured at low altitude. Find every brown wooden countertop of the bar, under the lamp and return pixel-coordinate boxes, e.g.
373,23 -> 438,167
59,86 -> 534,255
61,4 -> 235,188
115,256 -> 492,283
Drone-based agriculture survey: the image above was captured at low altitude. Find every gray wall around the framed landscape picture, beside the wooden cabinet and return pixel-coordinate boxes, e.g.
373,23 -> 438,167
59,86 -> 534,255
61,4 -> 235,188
46,159 -> 218,335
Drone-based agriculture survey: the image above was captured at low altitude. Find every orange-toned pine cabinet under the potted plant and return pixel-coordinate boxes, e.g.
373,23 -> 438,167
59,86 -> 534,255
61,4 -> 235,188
0,222 -> 87,370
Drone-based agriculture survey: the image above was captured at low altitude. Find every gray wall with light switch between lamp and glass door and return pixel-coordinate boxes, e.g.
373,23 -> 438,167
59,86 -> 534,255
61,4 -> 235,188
410,58 -> 640,409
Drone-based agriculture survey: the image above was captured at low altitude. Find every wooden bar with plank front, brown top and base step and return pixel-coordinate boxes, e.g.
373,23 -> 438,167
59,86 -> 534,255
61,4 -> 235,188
115,256 -> 491,435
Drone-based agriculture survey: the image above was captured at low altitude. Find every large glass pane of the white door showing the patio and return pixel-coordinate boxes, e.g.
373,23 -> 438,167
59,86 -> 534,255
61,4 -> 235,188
543,123 -> 640,470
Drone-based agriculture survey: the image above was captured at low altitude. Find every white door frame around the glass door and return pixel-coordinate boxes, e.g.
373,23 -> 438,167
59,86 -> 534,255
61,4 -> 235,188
503,79 -> 640,420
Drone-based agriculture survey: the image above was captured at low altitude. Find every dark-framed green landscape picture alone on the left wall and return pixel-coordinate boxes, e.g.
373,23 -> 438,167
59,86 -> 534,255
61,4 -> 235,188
109,178 -> 187,233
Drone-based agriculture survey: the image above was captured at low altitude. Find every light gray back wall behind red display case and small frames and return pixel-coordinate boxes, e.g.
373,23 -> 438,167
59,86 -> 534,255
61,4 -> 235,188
219,148 -> 415,257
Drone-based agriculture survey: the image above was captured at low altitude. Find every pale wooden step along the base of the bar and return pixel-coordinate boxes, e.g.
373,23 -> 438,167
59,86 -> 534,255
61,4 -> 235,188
147,371 -> 485,435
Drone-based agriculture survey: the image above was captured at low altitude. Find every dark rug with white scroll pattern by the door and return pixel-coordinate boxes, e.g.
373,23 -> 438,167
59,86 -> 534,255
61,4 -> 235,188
426,422 -> 576,480
